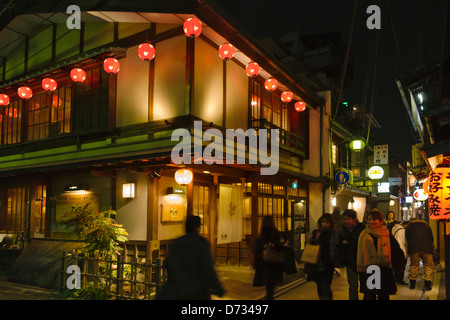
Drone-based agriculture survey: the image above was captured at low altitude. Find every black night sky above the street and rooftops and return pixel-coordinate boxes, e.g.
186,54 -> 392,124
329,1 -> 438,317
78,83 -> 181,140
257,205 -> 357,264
217,0 -> 450,160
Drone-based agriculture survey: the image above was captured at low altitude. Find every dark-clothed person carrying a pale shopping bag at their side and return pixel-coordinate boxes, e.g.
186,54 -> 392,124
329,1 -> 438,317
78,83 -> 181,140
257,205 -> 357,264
305,213 -> 339,300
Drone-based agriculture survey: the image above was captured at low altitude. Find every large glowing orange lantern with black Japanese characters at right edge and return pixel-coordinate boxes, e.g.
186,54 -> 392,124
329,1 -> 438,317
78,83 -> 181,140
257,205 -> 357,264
428,167 -> 450,220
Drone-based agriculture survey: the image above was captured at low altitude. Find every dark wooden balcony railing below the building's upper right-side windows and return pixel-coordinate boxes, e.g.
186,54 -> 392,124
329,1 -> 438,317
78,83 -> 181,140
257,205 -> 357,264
250,118 -> 306,159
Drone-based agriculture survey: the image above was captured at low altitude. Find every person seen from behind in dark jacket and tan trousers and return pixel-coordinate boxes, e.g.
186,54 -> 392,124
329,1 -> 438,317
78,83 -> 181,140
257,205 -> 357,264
405,220 -> 434,291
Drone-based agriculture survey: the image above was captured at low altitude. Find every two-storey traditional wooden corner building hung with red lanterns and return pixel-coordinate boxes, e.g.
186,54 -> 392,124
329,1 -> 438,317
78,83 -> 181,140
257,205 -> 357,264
0,0 -> 330,280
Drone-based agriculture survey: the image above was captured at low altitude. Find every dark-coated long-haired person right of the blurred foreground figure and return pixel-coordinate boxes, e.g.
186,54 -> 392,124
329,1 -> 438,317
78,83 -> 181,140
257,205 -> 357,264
253,216 -> 284,300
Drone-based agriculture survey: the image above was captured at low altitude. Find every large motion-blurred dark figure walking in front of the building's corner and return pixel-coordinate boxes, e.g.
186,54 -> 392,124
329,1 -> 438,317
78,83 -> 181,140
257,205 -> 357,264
156,216 -> 225,300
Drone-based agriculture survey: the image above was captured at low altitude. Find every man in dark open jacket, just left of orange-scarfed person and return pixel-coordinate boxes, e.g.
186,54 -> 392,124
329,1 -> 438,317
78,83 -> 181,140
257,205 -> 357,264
338,209 -> 364,300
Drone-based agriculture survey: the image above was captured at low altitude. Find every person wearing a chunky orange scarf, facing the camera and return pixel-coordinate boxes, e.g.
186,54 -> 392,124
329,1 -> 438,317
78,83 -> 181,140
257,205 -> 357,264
356,211 -> 397,300
